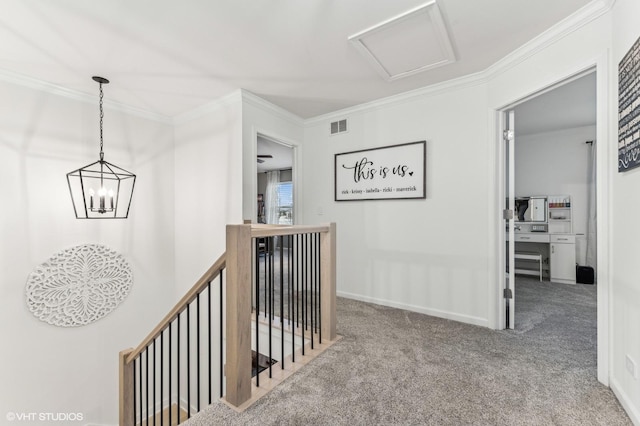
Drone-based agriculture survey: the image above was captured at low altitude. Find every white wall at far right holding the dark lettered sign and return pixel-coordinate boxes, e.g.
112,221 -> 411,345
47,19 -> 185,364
610,0 -> 640,424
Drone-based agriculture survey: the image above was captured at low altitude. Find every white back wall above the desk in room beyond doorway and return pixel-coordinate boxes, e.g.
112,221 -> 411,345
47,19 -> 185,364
515,126 -> 596,267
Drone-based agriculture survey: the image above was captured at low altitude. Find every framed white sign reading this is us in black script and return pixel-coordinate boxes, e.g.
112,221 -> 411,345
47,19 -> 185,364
334,141 -> 427,201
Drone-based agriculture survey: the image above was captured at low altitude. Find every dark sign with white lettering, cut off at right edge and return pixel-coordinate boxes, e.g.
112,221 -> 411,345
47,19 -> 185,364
618,38 -> 640,172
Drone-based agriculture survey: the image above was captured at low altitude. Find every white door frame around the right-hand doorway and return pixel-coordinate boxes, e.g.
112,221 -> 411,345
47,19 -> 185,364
489,53 -> 615,386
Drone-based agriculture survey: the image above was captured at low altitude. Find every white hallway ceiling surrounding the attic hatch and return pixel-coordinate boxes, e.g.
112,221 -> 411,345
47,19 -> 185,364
0,0 -> 595,118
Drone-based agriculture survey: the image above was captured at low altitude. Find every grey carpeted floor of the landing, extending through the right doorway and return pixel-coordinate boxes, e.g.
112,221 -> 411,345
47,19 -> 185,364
184,278 -> 631,426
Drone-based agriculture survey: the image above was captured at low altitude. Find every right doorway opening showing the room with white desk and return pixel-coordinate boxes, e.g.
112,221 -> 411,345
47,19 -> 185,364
499,70 -> 600,376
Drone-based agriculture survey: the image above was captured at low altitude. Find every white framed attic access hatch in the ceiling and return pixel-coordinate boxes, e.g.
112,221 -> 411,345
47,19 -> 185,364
349,0 -> 456,81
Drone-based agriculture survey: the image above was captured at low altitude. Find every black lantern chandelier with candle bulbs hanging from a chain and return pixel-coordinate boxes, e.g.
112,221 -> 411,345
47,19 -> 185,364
67,77 -> 136,219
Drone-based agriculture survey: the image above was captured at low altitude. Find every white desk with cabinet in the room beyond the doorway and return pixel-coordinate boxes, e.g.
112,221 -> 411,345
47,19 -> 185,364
507,232 -> 576,284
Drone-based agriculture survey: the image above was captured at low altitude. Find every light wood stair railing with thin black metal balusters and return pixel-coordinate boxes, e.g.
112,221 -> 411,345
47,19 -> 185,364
119,223 -> 337,426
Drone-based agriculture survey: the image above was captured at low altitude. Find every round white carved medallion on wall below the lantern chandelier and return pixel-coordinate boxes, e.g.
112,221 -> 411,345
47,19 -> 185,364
26,244 -> 133,327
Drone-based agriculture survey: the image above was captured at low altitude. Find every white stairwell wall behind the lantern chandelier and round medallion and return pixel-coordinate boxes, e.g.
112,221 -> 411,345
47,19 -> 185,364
0,82 -> 174,424
